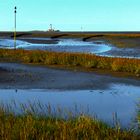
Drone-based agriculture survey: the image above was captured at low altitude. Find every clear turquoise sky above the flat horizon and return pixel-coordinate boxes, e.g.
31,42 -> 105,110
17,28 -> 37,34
0,0 -> 140,31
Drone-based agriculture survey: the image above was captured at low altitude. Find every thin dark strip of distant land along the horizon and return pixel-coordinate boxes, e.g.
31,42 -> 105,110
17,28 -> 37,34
0,31 -> 140,37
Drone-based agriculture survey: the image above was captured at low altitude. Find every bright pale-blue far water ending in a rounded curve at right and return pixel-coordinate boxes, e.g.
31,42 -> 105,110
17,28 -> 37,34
0,39 -> 111,53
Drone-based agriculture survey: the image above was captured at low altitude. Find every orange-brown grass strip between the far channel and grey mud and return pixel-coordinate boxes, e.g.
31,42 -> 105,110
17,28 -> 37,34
0,49 -> 140,77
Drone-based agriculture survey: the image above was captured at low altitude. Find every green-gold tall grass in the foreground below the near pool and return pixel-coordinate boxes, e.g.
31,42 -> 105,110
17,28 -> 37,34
0,105 -> 140,140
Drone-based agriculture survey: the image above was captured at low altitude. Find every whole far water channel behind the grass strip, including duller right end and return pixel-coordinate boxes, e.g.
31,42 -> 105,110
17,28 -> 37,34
0,38 -> 140,58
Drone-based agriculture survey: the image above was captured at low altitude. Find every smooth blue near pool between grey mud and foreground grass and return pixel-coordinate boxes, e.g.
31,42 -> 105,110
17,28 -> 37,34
0,84 -> 140,127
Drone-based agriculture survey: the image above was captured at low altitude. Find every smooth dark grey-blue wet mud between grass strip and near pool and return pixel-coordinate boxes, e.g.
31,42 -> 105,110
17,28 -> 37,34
0,63 -> 140,90
